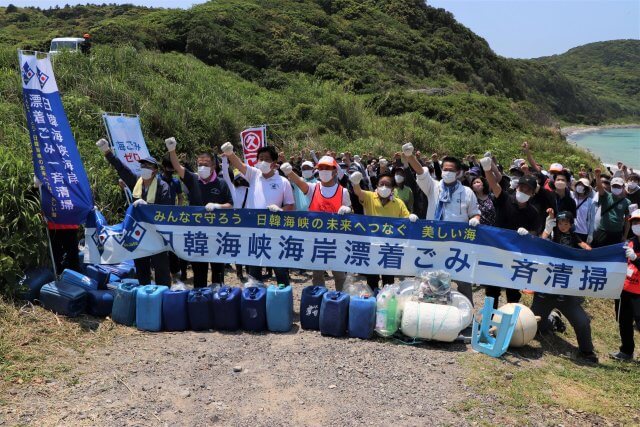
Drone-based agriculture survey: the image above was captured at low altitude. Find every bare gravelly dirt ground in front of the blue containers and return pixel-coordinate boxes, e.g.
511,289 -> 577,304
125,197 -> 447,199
0,273 -> 632,426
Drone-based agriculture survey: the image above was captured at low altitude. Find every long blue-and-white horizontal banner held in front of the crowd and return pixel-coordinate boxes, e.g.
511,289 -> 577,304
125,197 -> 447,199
85,205 -> 626,298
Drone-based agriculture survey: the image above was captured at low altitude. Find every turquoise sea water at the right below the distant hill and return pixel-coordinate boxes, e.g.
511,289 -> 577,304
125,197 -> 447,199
568,128 -> 640,170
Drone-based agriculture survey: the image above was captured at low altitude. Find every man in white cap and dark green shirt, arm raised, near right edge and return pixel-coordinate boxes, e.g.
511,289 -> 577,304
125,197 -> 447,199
593,168 -> 631,248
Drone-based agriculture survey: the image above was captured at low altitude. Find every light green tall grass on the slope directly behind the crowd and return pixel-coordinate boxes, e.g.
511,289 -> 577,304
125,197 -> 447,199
0,46 -> 594,293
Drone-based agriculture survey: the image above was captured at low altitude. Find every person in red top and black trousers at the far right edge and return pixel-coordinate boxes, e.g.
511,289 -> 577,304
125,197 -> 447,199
610,209 -> 640,361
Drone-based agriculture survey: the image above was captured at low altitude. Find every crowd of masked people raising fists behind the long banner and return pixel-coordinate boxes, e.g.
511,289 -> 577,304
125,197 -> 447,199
38,138 -> 640,362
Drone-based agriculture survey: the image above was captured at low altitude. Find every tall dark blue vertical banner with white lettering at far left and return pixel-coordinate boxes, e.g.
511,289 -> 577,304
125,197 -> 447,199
18,51 -> 93,224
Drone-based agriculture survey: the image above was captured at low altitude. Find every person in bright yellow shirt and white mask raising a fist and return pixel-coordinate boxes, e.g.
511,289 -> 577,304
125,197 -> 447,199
349,172 -> 418,290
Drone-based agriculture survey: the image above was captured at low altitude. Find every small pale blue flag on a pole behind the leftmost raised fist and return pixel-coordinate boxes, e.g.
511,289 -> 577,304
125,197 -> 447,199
102,113 -> 150,175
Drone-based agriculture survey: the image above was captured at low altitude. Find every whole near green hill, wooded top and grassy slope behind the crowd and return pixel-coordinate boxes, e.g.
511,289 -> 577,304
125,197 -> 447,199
0,0 -> 636,292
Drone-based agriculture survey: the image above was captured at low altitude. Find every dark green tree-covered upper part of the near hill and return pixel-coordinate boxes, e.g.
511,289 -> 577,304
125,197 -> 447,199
0,0 -> 637,124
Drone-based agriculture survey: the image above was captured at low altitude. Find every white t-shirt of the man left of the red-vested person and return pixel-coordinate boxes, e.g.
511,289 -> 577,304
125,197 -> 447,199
245,166 -> 295,209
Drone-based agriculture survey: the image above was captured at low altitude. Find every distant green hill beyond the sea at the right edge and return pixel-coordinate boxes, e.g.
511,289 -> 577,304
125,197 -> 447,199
535,40 -> 640,118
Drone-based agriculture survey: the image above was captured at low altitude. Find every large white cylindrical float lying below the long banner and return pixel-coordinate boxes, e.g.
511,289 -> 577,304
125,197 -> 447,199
401,301 -> 464,342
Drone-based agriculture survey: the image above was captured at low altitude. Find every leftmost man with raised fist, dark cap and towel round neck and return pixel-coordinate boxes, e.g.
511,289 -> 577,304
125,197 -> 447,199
96,138 -> 174,286
